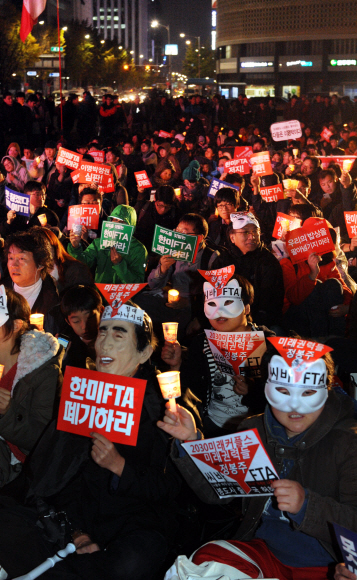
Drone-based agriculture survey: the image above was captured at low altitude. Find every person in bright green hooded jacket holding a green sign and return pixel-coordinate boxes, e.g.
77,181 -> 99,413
67,205 -> 148,284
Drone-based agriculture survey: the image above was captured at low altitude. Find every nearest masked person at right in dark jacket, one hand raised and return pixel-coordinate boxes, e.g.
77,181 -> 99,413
158,339 -> 357,580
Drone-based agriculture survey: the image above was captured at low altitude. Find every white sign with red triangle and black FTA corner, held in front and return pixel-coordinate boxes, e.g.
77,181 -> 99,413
182,429 -> 279,498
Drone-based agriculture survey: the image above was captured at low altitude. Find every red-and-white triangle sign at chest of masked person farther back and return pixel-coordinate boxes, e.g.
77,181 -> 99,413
205,330 -> 266,377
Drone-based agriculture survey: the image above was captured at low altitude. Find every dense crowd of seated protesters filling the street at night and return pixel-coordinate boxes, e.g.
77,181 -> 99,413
0,91 -> 357,580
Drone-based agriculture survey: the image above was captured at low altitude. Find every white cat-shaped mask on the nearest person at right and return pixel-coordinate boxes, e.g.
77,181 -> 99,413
265,355 -> 328,415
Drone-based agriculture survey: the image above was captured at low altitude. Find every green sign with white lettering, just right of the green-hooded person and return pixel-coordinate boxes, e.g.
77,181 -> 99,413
151,225 -> 201,262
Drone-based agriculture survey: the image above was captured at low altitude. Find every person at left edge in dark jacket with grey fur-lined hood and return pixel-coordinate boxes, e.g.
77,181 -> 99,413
0,286 -> 63,487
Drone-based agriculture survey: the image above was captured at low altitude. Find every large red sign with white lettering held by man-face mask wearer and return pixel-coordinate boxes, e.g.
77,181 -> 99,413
57,367 -> 146,445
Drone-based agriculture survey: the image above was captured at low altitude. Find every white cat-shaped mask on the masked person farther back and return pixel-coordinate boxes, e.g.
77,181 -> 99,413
203,280 -> 244,320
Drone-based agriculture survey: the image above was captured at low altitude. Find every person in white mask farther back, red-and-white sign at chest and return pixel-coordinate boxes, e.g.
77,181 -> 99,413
161,275 -> 274,437
